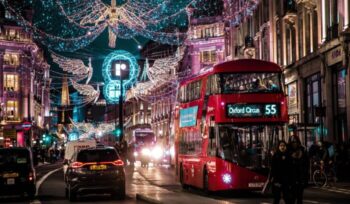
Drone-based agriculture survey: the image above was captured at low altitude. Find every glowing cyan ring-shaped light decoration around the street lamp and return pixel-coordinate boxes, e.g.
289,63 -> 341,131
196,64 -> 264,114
102,50 -> 139,103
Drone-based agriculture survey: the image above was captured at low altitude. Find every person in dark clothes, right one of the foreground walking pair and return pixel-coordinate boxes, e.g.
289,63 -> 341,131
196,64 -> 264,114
288,136 -> 309,204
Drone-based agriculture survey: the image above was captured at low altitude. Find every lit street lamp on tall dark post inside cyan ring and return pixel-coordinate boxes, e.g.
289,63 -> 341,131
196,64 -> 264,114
112,60 -> 129,141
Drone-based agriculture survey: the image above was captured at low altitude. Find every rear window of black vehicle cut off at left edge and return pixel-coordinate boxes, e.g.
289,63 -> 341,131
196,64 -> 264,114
0,149 -> 30,169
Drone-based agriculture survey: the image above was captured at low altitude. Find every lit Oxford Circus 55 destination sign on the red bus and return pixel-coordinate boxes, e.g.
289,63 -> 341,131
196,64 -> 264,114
226,104 -> 279,118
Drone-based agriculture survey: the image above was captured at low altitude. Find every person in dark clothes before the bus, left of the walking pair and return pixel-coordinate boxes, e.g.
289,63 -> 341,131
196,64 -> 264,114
270,140 -> 291,204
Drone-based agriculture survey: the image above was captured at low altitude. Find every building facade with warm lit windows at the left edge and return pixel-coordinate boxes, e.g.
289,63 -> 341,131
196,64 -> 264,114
0,6 -> 51,146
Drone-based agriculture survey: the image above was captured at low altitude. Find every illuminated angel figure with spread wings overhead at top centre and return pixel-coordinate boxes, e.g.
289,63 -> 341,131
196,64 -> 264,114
56,0 -> 196,48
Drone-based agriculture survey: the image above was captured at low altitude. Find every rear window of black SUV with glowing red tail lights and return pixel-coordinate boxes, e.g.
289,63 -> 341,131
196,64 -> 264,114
77,149 -> 119,162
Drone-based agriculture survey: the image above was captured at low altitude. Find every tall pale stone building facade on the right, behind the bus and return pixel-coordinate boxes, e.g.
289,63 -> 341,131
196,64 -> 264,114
225,0 -> 350,146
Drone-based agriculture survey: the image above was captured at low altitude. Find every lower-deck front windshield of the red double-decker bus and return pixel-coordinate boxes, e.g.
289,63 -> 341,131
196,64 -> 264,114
218,125 -> 282,169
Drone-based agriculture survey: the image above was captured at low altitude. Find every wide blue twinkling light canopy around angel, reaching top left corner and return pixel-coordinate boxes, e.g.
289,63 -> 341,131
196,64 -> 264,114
1,0 -> 203,52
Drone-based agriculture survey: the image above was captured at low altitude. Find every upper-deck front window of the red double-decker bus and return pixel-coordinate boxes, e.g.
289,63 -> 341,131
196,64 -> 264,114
216,72 -> 282,94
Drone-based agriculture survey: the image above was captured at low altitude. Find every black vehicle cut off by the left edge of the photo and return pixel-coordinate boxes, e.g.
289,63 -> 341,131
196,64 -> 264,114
0,147 -> 36,198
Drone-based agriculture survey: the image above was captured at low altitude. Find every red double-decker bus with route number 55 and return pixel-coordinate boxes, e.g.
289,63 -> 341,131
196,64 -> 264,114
175,59 -> 288,191
